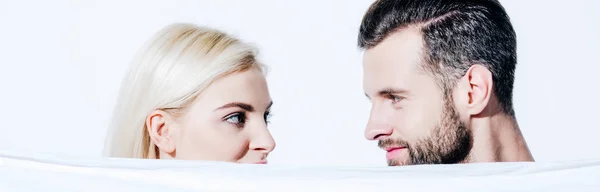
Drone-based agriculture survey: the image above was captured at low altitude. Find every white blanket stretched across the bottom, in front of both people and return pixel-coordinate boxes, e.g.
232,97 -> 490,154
0,151 -> 600,192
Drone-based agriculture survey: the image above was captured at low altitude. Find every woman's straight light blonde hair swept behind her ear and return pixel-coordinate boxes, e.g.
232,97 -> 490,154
104,23 -> 266,158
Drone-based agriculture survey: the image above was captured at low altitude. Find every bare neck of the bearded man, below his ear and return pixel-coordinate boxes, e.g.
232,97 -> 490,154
467,113 -> 534,163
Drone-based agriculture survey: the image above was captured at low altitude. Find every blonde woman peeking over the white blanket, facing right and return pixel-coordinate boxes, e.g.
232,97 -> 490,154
105,23 -> 275,164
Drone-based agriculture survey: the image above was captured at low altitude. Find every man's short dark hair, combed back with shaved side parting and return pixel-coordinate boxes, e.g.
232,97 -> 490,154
358,0 -> 517,117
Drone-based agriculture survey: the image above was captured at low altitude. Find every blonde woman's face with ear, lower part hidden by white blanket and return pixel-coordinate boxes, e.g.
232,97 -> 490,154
149,69 -> 275,164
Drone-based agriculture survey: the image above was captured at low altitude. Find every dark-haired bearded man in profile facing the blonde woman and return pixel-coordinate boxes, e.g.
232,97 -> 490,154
358,0 -> 534,166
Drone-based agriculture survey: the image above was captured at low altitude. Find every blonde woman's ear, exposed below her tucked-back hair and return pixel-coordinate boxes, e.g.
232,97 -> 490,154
146,110 -> 175,154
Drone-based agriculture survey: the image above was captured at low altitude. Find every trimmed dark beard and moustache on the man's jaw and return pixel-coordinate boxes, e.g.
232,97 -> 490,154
379,98 -> 473,166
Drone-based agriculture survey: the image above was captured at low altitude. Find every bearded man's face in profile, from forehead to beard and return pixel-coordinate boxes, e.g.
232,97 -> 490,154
363,29 -> 472,166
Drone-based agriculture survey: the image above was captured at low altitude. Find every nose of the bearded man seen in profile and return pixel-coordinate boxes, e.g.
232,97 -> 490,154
365,106 -> 394,140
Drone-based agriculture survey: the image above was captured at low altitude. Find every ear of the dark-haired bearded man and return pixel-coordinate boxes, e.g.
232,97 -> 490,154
465,64 -> 494,115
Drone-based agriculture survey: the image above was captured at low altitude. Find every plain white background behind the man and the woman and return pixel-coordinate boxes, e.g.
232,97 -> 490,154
0,0 -> 600,166
